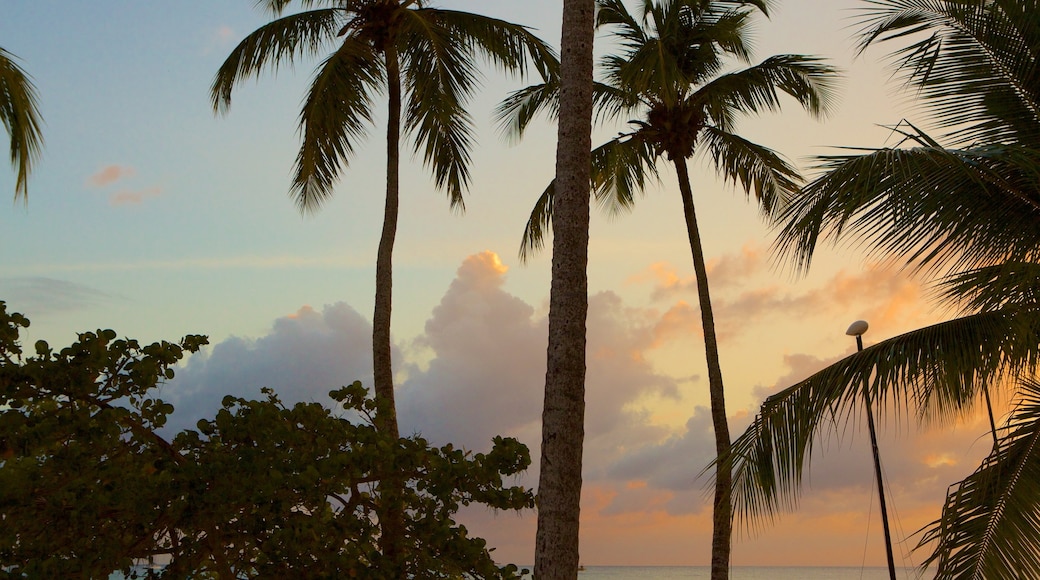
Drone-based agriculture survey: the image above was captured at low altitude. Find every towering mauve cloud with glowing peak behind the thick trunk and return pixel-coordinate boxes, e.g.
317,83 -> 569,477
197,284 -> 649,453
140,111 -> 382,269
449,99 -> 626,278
398,252 -> 677,453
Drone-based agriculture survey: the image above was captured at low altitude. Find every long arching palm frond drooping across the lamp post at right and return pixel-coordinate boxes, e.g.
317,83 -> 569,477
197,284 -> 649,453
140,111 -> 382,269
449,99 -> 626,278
732,309 -> 1040,530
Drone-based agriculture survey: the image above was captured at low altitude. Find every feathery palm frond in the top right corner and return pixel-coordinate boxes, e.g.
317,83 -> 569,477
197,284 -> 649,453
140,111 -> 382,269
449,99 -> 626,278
859,0 -> 1040,146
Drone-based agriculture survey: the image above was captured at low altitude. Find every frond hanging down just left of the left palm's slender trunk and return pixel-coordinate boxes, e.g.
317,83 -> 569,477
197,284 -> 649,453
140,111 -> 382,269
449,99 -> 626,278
289,36 -> 384,211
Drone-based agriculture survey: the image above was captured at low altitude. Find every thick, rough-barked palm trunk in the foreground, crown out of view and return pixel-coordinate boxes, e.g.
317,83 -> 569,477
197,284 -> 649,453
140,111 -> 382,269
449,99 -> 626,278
535,0 -> 595,580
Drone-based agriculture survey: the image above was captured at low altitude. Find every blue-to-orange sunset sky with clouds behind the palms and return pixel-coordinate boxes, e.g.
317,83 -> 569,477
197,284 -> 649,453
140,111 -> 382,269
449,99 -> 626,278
0,0 -> 987,565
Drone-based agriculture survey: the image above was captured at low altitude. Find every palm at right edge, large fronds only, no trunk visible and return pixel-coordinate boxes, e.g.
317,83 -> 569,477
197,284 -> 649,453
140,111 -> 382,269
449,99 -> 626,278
733,0 -> 1040,578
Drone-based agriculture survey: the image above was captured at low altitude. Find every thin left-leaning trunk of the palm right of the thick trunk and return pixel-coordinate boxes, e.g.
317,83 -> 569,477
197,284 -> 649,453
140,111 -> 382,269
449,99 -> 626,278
673,157 -> 733,580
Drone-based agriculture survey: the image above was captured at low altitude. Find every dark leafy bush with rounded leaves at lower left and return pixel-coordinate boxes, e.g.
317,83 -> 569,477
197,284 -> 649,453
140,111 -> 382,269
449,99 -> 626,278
0,301 -> 534,578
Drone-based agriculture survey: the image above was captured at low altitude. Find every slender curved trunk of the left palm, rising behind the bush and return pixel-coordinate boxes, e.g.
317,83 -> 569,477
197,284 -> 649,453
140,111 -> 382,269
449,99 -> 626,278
372,44 -> 405,577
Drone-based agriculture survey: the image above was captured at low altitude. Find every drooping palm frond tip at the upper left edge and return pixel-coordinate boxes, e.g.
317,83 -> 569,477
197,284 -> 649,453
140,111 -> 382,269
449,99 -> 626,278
0,48 -> 44,206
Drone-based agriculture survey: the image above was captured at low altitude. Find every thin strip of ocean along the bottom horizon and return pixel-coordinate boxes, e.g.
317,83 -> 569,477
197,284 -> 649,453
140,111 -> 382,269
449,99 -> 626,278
515,565 -> 928,580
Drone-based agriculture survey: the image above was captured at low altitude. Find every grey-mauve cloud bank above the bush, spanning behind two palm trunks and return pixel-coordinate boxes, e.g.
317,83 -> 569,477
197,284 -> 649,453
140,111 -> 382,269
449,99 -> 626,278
166,252 -> 694,472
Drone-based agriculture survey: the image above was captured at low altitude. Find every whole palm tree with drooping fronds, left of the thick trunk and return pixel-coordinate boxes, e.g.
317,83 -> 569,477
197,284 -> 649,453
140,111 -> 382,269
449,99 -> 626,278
211,0 -> 557,577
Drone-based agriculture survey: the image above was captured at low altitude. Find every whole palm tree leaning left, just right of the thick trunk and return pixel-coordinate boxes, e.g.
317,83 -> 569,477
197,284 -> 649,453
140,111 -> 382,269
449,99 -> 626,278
498,0 -> 834,578
